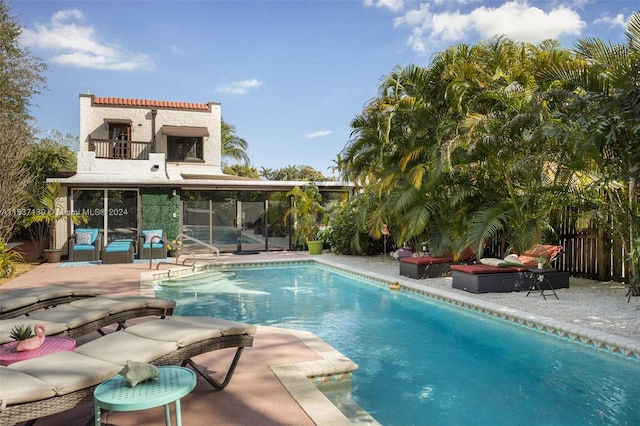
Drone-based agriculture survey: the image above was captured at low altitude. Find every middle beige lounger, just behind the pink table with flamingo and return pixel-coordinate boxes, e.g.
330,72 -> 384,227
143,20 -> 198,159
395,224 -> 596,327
0,295 -> 176,343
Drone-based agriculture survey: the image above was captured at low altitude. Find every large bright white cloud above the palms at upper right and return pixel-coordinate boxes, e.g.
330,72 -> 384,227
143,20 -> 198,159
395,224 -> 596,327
394,0 -> 584,53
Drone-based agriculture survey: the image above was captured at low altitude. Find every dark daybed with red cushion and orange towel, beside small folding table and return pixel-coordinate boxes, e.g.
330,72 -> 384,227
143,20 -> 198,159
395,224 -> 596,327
450,245 -> 569,293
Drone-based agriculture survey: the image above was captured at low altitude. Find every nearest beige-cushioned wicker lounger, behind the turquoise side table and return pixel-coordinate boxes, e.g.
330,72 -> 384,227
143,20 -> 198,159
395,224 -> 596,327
0,317 -> 256,425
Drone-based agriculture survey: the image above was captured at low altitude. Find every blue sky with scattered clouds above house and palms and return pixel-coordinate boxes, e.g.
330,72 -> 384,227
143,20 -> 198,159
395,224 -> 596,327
10,0 -> 640,176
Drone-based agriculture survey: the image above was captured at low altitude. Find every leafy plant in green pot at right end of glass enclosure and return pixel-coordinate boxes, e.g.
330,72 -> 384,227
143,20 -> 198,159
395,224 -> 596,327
284,183 -> 328,254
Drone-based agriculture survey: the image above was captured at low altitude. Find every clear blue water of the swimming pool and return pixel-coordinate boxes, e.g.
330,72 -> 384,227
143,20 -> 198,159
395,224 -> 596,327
156,264 -> 640,425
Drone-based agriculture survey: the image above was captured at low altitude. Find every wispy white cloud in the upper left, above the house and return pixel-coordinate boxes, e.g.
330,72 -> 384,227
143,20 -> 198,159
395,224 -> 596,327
21,9 -> 154,70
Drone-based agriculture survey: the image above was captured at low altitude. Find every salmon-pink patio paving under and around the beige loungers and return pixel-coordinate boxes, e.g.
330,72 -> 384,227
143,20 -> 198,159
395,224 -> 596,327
0,253 -> 349,426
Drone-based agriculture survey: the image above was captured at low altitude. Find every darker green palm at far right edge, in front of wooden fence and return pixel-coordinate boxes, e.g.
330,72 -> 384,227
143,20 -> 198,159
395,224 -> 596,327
549,12 -> 640,295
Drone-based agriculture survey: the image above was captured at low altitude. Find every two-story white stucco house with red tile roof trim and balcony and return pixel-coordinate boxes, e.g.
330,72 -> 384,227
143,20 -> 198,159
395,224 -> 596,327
54,95 -> 353,252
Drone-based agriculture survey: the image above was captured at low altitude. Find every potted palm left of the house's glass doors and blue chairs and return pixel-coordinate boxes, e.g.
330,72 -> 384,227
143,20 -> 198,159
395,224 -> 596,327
25,182 -> 88,263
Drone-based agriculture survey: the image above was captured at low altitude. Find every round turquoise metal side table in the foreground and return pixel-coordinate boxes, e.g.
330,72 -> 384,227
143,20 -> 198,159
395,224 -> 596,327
93,366 -> 196,426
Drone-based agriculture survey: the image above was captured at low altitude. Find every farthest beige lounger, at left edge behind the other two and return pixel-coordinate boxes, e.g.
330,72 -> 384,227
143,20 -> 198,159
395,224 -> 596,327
0,285 -> 102,319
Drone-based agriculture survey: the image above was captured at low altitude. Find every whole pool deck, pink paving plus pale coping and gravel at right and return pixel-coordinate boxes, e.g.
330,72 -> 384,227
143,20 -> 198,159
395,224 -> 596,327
0,252 -> 640,426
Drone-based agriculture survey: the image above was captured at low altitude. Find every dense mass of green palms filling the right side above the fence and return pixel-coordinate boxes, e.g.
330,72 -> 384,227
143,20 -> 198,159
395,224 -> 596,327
337,13 -> 640,292
